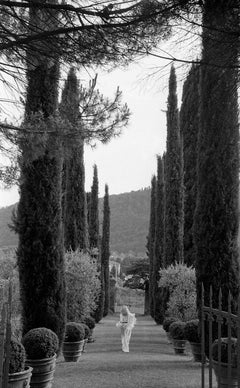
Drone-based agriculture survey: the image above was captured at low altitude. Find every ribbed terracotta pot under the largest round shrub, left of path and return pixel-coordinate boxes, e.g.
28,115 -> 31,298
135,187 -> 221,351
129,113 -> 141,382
26,354 -> 56,388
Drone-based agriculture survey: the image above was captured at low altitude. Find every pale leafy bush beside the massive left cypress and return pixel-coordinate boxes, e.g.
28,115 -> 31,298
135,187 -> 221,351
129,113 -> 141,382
65,250 -> 100,322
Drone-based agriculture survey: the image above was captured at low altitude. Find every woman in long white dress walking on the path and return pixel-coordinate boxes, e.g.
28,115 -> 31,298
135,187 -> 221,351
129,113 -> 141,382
116,305 -> 136,353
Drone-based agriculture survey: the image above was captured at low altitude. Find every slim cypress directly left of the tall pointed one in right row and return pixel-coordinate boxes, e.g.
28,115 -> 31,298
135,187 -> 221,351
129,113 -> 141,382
152,156 -> 164,323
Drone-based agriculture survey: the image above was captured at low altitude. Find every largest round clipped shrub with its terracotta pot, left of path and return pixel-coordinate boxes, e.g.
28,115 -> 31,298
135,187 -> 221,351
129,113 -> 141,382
22,327 -> 59,388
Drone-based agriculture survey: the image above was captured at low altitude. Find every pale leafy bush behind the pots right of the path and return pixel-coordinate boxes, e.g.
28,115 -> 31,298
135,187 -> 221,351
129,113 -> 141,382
159,263 -> 197,321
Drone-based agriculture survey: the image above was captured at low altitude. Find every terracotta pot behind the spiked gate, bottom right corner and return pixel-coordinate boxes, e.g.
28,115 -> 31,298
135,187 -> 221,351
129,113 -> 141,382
212,360 -> 238,388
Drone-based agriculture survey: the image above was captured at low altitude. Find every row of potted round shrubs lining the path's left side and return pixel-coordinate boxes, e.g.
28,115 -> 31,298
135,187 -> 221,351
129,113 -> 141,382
8,317 -> 95,388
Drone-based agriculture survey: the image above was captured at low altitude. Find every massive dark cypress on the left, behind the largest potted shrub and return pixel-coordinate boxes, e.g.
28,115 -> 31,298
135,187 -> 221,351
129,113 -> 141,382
17,1 -> 65,343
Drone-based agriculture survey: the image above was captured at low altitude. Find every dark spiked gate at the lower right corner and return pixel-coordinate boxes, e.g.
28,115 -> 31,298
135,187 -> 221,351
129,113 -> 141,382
201,287 -> 240,388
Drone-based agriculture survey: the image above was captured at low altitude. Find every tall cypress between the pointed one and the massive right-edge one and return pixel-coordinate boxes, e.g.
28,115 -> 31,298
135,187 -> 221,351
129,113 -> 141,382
180,65 -> 200,265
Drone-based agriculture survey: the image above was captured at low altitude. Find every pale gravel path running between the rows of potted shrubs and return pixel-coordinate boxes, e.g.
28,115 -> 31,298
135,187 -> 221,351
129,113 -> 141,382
53,316 -> 215,388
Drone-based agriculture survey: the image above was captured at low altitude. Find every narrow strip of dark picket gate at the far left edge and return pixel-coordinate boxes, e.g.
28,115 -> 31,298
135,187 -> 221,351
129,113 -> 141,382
0,282 -> 12,388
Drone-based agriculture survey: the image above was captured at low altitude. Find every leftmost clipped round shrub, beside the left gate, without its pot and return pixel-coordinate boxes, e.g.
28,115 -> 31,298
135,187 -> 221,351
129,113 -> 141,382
8,338 -> 26,373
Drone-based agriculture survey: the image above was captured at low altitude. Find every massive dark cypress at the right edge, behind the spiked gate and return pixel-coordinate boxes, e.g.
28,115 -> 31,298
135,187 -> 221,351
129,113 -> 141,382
194,0 -> 239,316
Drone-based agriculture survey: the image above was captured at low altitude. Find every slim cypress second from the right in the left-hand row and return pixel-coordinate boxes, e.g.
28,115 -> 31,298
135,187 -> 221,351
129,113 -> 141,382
88,164 -> 99,249
